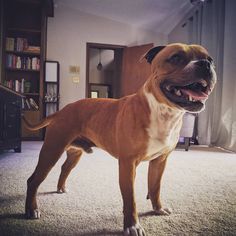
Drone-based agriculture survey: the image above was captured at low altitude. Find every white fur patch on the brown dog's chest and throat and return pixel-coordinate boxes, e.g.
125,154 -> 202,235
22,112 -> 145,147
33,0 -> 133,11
145,92 -> 184,160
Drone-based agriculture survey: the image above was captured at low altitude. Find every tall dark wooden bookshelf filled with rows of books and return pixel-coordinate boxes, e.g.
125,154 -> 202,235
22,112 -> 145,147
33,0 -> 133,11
0,0 -> 53,140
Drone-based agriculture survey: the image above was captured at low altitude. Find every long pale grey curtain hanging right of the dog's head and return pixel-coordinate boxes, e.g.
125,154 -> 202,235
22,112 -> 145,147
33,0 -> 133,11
187,0 -> 236,151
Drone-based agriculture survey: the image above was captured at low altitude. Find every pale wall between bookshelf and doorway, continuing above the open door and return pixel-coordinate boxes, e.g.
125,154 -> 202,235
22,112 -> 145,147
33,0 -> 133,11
47,6 -> 167,107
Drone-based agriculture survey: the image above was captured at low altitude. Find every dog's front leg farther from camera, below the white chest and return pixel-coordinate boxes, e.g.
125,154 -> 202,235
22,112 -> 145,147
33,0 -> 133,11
148,153 -> 171,215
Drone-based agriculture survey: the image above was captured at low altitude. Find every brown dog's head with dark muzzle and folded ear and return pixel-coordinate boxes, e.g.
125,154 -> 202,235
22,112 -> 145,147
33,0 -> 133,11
144,44 -> 216,112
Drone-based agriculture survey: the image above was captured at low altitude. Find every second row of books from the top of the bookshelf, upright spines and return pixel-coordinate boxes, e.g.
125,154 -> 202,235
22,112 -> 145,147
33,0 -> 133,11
6,54 -> 40,70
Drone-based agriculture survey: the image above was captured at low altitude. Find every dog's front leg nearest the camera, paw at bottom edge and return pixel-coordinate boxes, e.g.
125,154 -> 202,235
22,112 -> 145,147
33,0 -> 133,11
119,160 -> 145,236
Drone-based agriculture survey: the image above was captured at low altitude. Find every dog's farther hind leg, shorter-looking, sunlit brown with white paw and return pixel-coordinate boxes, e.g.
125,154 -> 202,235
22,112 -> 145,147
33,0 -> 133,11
57,148 -> 83,193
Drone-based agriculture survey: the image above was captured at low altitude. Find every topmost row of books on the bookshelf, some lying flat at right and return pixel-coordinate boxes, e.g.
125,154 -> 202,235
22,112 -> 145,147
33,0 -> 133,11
6,37 -> 40,53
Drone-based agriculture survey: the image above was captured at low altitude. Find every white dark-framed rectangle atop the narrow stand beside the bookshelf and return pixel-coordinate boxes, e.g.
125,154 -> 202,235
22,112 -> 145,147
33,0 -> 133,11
45,61 -> 59,83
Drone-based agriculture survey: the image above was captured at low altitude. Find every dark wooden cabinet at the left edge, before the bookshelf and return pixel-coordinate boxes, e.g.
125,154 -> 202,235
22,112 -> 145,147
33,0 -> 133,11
0,85 -> 23,152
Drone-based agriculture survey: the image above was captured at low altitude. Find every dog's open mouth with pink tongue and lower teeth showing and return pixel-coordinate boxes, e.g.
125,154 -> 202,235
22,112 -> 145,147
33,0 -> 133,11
161,79 -> 211,111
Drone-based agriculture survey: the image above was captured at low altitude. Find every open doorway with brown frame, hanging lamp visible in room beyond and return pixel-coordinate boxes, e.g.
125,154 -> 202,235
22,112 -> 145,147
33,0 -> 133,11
86,43 -> 125,98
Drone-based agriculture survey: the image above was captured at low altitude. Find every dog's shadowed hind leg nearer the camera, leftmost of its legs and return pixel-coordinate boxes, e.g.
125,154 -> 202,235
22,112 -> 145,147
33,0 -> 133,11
25,141 -> 65,219
